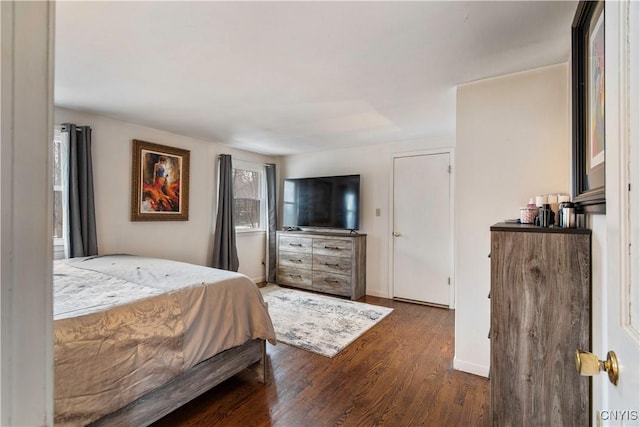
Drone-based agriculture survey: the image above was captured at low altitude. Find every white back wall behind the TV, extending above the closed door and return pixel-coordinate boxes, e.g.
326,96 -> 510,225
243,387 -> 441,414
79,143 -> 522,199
280,137 -> 455,298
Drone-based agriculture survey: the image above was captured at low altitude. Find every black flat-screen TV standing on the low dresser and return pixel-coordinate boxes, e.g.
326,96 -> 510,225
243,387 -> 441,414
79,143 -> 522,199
282,175 -> 360,230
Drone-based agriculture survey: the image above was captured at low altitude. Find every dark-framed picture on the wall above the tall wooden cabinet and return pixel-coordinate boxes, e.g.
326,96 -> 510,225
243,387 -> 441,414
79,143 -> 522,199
571,1 -> 606,213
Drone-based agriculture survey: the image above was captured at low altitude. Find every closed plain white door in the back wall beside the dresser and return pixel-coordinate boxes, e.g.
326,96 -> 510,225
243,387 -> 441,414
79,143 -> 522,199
392,153 -> 452,306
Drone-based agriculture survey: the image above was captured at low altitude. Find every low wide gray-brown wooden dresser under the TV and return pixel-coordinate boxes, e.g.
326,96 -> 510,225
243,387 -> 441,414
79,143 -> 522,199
276,231 -> 367,300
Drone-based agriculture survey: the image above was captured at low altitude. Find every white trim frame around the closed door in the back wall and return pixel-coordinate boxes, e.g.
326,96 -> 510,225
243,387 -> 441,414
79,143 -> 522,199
387,147 -> 457,310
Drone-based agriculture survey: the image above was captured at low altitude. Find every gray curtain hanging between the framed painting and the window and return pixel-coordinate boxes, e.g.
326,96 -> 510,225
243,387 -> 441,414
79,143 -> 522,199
213,154 -> 240,271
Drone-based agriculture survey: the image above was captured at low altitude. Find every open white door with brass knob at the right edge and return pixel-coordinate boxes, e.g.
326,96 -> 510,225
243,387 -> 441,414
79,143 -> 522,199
594,1 -> 640,426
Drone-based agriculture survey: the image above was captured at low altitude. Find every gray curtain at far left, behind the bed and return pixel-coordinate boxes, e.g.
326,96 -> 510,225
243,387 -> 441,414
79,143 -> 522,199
62,123 -> 98,258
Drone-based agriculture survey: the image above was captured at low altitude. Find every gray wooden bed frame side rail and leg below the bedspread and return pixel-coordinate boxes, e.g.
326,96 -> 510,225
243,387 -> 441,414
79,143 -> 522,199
90,339 -> 267,426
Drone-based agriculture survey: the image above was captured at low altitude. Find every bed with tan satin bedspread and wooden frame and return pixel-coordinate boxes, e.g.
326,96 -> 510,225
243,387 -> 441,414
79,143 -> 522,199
54,255 -> 275,426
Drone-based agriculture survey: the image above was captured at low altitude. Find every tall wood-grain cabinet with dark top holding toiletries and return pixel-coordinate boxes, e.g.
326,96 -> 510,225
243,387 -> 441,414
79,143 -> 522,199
490,224 -> 591,427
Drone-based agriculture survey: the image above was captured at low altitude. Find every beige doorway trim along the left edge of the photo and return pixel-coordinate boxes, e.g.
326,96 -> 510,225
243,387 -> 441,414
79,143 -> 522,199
0,1 -> 55,426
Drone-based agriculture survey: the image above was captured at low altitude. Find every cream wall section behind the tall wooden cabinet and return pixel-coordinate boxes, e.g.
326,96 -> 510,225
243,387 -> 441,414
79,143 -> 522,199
454,64 -> 571,375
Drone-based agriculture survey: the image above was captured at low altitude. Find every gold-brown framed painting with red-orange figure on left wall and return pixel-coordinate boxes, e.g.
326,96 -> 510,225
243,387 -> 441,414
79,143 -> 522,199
131,139 -> 190,221
